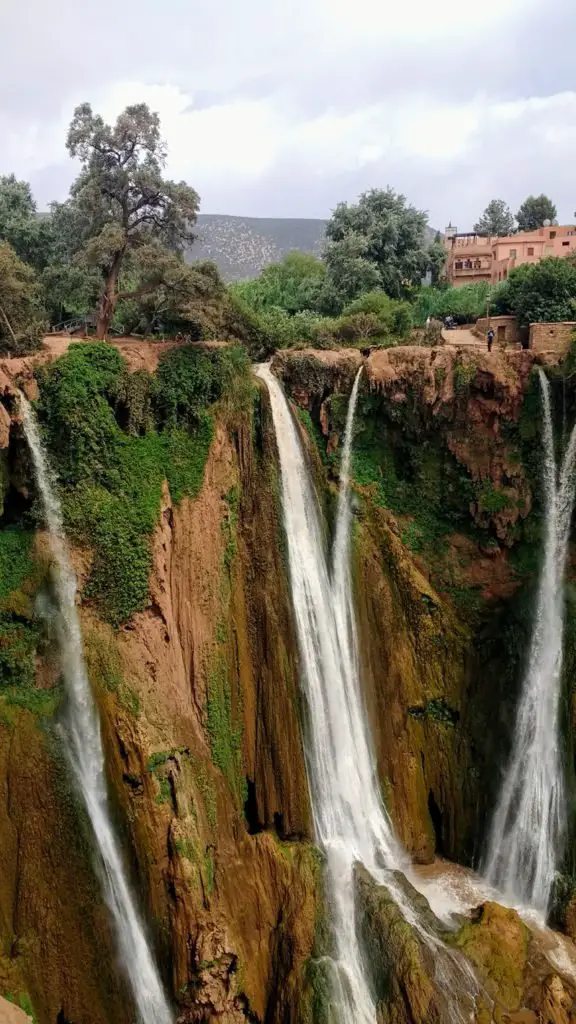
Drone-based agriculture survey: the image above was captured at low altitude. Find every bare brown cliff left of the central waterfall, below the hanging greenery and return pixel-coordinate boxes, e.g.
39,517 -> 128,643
0,348 -> 321,1024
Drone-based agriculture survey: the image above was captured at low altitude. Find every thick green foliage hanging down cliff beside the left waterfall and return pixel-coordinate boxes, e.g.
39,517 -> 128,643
38,343 -> 248,625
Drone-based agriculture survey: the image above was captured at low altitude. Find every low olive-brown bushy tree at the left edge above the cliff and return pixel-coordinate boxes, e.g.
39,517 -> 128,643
0,242 -> 45,355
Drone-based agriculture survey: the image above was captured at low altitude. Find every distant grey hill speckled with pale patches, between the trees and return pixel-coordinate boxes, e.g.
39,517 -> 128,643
187,213 -> 326,281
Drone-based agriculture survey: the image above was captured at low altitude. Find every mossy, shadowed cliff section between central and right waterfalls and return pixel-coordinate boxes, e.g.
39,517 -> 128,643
274,347 -> 561,863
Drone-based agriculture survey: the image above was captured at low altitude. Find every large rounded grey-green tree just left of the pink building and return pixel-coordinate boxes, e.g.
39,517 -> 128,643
324,188 -> 427,301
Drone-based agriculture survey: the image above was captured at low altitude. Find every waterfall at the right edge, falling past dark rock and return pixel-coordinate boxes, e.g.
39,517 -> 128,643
484,370 -> 576,914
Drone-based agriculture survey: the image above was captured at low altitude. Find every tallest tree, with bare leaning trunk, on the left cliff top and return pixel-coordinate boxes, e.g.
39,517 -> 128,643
66,103 -> 200,338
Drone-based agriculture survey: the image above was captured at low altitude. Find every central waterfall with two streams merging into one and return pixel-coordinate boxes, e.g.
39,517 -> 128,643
258,367 -> 477,1024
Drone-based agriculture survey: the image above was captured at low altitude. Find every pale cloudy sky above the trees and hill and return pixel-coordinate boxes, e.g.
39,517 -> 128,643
0,0 -> 576,229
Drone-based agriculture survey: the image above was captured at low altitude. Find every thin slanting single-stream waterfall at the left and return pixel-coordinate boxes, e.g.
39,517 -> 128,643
20,395 -> 172,1024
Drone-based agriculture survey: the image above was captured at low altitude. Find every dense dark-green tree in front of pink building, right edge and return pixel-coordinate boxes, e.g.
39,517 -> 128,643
505,256 -> 576,326
